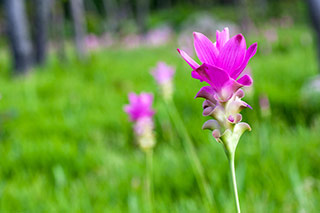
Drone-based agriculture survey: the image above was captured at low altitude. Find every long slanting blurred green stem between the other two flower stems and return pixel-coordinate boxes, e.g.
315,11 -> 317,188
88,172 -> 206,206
166,101 -> 214,211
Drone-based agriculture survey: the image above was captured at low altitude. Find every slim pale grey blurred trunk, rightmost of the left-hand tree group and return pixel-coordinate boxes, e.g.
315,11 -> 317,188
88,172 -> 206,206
70,0 -> 87,59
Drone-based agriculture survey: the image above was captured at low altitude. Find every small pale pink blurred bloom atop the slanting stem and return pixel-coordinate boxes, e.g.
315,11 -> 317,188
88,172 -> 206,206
151,62 -> 175,85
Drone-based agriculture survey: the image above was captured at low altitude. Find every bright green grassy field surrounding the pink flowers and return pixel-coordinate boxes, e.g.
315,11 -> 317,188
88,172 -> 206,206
0,26 -> 320,212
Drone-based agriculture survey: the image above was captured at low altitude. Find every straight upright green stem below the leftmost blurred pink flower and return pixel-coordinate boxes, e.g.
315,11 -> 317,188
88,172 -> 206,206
146,149 -> 153,212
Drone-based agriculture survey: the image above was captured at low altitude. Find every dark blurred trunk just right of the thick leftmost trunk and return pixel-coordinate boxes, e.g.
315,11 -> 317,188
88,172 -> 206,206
33,0 -> 52,65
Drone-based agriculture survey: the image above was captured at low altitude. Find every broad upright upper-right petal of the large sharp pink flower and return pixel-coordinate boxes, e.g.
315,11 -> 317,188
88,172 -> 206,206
216,34 -> 246,74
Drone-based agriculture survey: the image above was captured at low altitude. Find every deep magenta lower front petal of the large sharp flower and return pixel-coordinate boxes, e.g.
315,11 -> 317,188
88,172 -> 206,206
195,63 -> 230,92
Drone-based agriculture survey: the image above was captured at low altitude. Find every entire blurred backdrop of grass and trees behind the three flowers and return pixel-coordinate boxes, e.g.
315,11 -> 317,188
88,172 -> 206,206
0,0 -> 320,212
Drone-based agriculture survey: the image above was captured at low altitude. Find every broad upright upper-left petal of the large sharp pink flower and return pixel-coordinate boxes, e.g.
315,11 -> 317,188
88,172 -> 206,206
193,32 -> 218,65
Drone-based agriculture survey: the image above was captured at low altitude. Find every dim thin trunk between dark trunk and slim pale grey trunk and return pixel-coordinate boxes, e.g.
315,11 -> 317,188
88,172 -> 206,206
51,0 -> 66,61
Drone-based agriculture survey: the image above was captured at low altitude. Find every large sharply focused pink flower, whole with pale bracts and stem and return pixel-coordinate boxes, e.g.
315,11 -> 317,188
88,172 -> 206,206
178,28 -> 257,212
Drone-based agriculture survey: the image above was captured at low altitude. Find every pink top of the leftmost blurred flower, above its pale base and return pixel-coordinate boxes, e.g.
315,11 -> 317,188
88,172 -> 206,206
124,92 -> 154,122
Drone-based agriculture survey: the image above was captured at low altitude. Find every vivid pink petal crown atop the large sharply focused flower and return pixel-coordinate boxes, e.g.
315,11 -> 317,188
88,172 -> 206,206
178,28 -> 257,102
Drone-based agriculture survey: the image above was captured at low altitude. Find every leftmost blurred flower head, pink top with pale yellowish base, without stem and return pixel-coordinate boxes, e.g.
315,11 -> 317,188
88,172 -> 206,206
124,93 -> 155,151
